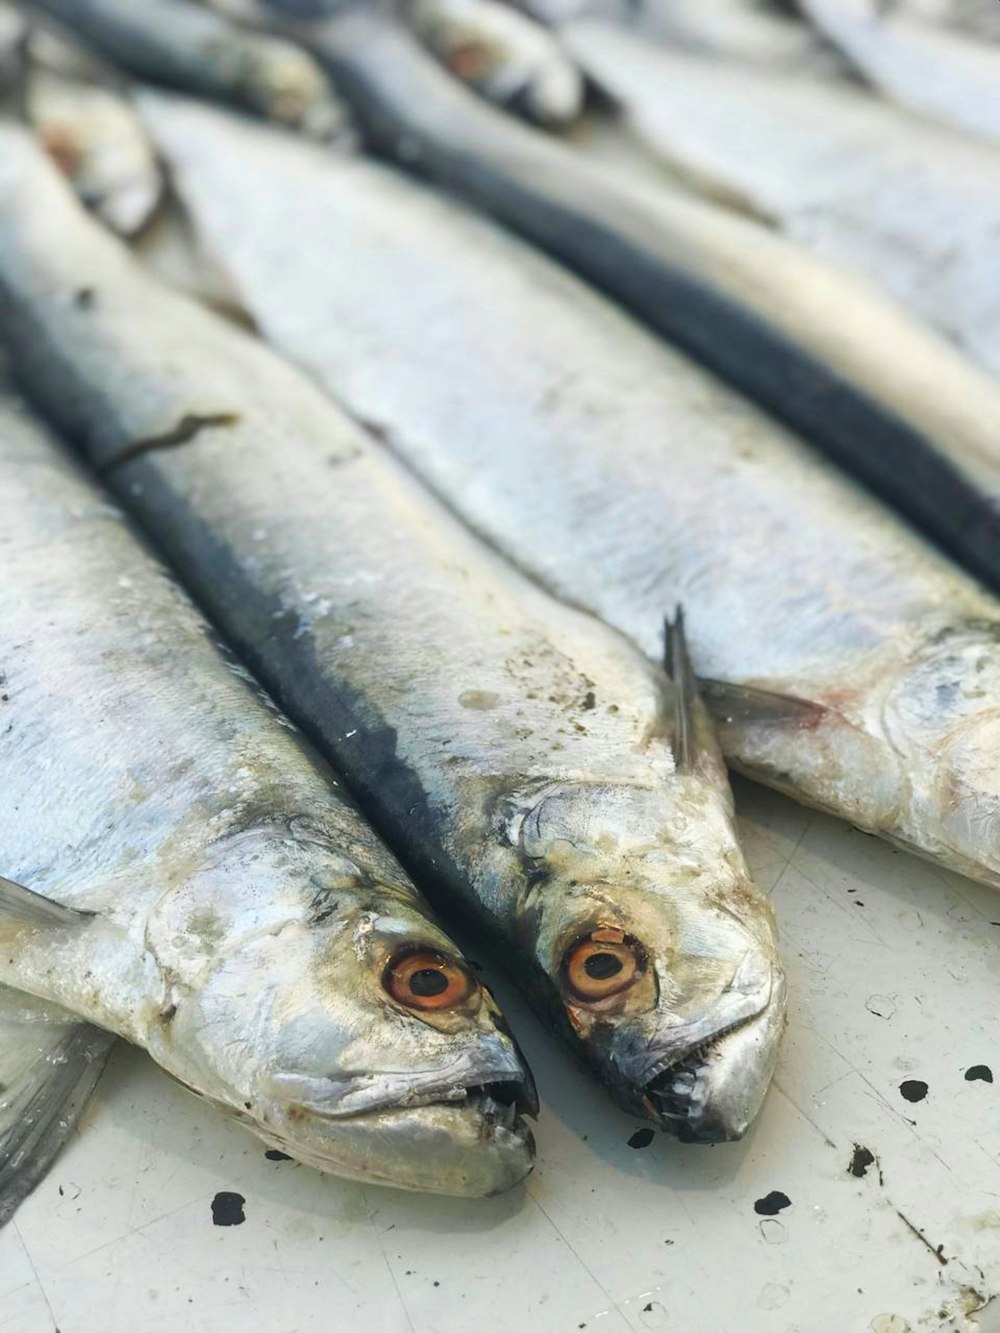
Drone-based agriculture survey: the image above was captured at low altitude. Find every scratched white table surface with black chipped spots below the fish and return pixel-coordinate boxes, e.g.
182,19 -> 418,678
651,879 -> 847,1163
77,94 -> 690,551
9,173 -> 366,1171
0,784 -> 1000,1333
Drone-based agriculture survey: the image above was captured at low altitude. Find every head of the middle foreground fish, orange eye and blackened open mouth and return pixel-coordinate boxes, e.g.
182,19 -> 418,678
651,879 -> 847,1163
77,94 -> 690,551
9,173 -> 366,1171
519,776 -> 785,1142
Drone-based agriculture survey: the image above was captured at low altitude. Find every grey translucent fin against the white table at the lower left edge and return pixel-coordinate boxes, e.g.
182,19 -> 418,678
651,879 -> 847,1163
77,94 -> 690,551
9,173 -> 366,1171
0,986 -> 116,1226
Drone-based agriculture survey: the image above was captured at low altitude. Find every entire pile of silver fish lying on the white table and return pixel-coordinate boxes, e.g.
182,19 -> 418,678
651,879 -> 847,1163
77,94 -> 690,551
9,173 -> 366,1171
0,0 -> 1000,1218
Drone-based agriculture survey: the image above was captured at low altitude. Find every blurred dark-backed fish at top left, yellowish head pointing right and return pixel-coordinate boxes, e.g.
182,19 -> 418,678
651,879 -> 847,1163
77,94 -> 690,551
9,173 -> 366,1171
35,0 -> 347,139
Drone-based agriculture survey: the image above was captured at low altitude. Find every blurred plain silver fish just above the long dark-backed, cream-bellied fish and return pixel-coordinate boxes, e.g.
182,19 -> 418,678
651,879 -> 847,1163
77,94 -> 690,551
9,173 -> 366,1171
563,23 -> 1000,372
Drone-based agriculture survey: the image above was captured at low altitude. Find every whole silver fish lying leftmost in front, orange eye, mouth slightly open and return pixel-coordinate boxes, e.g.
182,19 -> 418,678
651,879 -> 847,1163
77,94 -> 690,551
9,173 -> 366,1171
0,375 -> 537,1217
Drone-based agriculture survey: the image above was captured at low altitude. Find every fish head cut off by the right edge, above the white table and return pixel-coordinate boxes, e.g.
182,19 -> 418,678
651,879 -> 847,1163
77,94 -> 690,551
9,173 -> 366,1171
883,620 -> 1000,888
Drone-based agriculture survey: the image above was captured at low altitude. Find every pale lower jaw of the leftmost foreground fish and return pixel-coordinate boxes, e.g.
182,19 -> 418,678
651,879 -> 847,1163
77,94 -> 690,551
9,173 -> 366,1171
254,1084 -> 535,1198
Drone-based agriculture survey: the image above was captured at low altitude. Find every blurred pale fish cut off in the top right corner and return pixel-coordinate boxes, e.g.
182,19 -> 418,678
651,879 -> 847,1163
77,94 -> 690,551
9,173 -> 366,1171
800,0 -> 1000,144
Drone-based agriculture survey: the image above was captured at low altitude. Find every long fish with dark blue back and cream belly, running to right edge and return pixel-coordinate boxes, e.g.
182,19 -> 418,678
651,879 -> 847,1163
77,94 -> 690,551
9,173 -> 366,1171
264,13 -> 1000,589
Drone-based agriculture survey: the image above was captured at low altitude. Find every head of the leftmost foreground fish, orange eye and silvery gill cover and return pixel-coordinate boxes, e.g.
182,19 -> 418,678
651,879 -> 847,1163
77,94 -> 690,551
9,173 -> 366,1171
151,853 -> 537,1196
